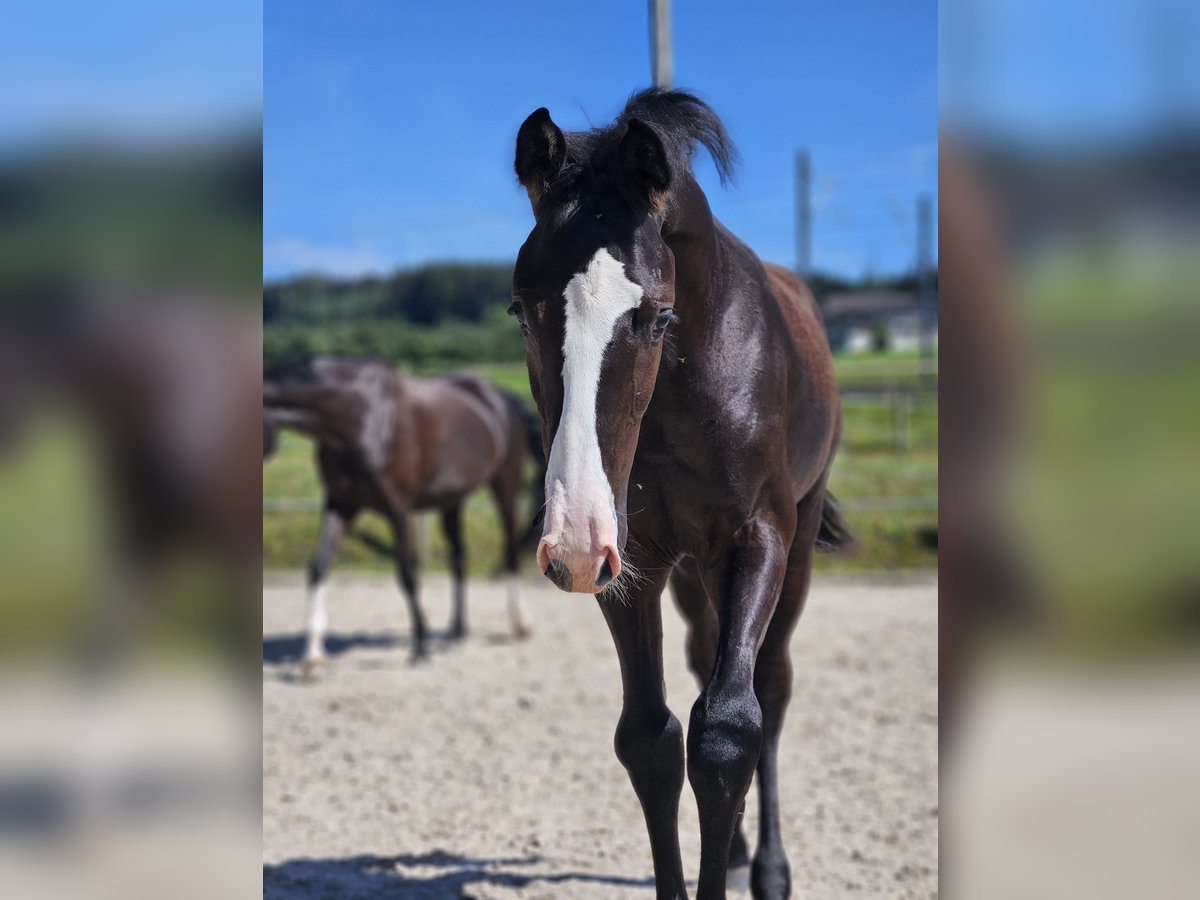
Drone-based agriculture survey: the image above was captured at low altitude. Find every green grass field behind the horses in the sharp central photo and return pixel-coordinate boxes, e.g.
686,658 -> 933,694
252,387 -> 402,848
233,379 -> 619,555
263,355 -> 937,575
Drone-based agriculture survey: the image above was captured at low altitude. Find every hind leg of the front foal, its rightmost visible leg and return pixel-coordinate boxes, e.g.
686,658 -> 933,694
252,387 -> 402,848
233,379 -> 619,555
750,494 -> 824,900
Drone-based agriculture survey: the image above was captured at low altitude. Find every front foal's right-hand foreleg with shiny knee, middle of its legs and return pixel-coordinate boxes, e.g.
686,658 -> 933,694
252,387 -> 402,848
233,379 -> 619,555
688,517 -> 793,900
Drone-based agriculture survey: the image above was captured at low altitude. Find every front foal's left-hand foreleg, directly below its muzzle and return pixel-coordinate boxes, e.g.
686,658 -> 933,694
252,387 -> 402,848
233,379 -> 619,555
600,571 -> 688,900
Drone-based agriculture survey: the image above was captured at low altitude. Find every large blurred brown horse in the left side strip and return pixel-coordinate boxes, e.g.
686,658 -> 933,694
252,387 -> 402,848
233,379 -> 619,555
0,300 -> 262,677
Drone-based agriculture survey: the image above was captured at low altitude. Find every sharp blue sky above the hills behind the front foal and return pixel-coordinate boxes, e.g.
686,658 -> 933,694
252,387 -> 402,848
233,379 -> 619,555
263,0 -> 937,278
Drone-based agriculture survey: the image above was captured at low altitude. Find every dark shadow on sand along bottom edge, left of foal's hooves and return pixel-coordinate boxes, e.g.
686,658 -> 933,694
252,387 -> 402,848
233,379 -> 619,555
263,851 -> 654,900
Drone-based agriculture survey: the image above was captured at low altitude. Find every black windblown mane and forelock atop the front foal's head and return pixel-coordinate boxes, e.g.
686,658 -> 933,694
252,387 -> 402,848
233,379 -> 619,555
563,88 -> 738,185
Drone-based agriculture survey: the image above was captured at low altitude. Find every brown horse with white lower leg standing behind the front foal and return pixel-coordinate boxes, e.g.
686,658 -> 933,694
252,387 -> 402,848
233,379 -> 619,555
263,358 -> 544,672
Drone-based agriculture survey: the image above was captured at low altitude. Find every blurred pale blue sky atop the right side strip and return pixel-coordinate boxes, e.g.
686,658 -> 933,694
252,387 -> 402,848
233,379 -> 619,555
940,0 -> 1200,146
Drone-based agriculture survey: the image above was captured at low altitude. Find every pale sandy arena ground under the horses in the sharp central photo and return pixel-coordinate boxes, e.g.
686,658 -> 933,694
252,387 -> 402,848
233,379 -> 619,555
263,577 -> 938,900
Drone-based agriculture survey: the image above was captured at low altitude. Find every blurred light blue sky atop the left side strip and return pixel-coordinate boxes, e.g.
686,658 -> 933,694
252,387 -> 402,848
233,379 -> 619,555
0,0 -> 263,144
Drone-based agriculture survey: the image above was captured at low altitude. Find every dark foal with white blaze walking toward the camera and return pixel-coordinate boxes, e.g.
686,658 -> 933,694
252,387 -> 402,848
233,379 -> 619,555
511,89 -> 846,900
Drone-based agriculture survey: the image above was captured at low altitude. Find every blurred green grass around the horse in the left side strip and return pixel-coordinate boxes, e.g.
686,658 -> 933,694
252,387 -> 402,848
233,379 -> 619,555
0,412 -> 247,668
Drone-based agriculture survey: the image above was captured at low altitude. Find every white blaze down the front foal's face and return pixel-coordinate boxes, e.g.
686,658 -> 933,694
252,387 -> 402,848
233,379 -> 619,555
545,248 -> 642,550
